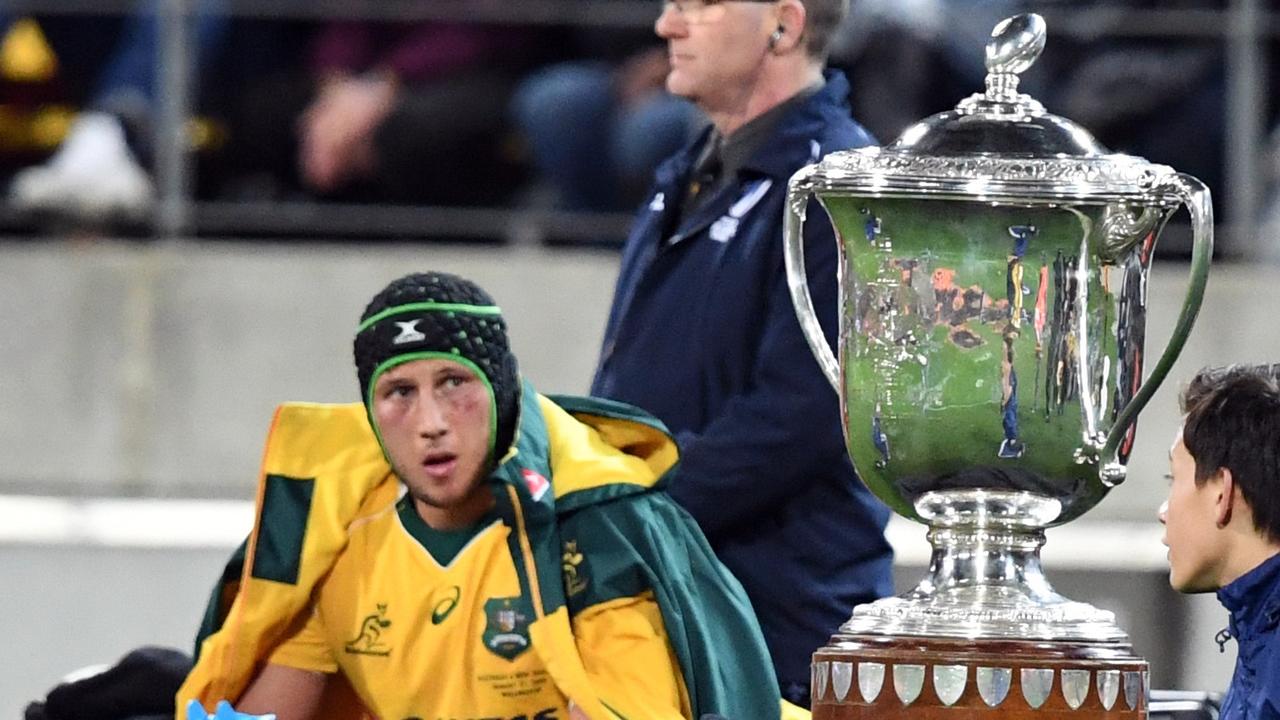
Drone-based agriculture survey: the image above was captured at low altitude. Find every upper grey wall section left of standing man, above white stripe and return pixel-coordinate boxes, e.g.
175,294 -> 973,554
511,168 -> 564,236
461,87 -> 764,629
0,243 -> 616,497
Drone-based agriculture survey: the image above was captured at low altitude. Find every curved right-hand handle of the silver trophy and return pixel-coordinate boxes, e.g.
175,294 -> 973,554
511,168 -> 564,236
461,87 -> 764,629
1101,173 -> 1213,487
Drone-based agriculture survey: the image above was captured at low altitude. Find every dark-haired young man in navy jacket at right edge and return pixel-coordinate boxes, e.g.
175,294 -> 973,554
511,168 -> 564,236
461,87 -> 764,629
1160,365 -> 1280,720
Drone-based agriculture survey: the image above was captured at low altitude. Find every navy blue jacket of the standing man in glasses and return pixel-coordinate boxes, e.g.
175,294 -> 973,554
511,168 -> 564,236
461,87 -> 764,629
591,72 -> 892,700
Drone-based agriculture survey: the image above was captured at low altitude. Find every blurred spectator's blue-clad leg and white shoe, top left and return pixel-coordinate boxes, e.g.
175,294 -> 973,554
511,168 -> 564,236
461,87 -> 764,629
0,0 -> 228,220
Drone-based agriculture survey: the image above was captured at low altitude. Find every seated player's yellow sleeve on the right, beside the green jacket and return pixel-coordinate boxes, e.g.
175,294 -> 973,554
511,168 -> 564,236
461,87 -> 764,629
573,593 -> 690,720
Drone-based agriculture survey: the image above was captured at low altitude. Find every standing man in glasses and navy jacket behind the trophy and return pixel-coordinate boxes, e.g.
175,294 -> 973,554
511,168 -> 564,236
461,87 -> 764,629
593,0 -> 892,706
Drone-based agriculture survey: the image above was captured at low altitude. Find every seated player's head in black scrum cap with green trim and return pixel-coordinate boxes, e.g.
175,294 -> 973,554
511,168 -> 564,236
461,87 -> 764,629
355,273 -> 520,527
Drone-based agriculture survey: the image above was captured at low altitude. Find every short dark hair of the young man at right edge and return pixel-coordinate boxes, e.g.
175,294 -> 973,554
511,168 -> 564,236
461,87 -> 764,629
1181,364 -> 1280,542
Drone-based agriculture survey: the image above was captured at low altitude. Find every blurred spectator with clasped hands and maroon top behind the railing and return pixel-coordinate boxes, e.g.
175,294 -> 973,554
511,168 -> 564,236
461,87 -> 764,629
230,22 -> 555,204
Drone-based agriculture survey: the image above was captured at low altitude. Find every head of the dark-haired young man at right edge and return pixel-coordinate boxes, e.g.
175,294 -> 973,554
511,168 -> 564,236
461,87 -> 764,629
1160,365 -> 1280,592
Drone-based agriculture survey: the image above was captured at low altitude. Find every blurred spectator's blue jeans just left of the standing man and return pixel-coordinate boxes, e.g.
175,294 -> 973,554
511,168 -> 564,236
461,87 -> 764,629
512,0 -> 707,217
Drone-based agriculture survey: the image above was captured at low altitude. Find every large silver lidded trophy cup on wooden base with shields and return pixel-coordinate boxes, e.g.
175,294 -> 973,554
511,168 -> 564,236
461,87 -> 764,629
786,14 -> 1212,719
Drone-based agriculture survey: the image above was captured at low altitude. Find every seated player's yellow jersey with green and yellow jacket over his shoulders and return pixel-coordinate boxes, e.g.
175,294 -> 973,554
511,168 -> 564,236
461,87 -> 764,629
175,394 -> 790,720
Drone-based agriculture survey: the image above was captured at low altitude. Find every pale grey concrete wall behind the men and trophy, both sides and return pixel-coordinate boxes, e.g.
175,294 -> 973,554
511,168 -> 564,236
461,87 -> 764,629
0,243 -> 1280,716
